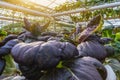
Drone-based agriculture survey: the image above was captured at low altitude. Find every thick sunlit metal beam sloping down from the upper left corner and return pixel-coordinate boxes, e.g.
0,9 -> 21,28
0,1 -> 50,17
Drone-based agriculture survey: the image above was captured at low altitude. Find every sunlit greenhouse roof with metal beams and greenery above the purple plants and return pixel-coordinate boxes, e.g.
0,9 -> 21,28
0,0 -> 120,25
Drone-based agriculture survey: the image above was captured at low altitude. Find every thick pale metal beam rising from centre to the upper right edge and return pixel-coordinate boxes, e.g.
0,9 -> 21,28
51,2 -> 120,17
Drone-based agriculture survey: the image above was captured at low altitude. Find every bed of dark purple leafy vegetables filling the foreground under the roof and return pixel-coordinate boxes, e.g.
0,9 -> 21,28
0,15 -> 120,80
